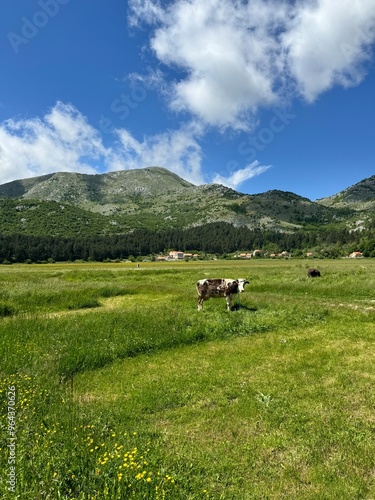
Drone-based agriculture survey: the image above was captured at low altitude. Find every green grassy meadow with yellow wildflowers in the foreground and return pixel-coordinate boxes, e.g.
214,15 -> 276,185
0,259 -> 375,500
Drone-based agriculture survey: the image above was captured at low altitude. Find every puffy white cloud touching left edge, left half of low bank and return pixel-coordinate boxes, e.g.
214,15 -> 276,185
0,102 -> 105,183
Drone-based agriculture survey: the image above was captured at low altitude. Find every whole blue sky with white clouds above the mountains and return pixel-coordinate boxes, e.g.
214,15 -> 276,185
0,0 -> 375,200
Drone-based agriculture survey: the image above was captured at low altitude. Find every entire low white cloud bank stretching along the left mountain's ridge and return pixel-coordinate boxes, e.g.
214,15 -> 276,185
0,102 -> 209,184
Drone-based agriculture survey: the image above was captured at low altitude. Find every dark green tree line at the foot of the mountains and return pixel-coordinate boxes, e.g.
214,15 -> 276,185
0,222 -> 375,263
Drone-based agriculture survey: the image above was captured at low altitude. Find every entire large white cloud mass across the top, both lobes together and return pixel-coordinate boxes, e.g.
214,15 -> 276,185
129,0 -> 375,130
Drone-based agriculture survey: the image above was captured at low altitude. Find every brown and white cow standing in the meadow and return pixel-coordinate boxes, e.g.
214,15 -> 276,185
196,278 -> 249,311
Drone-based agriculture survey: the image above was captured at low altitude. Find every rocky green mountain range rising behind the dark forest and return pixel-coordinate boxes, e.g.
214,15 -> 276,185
0,167 -> 375,236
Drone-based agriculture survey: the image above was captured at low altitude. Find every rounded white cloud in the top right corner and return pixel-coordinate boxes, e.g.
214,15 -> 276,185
283,0 -> 375,101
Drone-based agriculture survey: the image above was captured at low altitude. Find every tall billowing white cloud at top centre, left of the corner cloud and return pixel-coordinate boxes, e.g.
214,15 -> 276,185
144,0 -> 284,129
